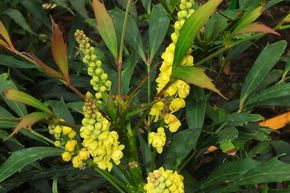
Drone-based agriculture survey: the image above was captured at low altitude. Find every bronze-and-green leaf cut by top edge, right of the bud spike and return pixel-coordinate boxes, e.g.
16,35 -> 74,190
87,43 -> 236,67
92,0 -> 118,60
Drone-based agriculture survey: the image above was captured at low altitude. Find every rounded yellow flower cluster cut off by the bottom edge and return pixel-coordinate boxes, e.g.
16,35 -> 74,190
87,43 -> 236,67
144,167 -> 184,193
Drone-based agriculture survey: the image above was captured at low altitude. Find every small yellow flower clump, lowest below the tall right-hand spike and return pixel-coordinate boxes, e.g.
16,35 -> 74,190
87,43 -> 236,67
148,127 -> 166,153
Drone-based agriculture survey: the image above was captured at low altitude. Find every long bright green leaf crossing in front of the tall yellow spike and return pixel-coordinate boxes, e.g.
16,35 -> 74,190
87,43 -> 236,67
173,0 -> 222,69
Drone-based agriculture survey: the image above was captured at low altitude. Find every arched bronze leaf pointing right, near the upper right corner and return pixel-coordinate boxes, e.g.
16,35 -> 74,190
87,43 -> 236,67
235,23 -> 280,35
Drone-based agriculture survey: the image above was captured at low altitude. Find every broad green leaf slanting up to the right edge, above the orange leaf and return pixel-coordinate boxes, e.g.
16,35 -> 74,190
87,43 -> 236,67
240,40 -> 287,109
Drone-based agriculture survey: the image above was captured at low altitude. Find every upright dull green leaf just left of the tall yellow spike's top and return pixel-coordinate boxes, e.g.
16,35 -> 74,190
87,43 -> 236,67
149,4 -> 170,61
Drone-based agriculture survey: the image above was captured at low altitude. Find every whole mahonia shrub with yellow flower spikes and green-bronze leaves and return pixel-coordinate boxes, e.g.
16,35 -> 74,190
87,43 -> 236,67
0,0 -> 290,193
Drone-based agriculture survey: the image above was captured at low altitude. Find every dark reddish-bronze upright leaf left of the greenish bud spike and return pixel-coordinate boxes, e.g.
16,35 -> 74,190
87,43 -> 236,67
51,19 -> 69,82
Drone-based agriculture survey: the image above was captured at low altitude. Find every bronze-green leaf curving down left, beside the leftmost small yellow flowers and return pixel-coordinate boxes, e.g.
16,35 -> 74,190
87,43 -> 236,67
10,112 -> 51,136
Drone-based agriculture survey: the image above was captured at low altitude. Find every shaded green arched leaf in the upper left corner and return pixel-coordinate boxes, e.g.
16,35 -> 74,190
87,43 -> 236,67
3,9 -> 36,35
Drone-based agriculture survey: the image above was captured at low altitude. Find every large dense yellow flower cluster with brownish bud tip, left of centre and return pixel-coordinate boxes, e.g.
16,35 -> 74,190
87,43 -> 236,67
80,92 -> 124,171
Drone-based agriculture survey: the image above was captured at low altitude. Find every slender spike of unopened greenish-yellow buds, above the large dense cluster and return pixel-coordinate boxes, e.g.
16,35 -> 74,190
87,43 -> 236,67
74,30 -> 112,99
